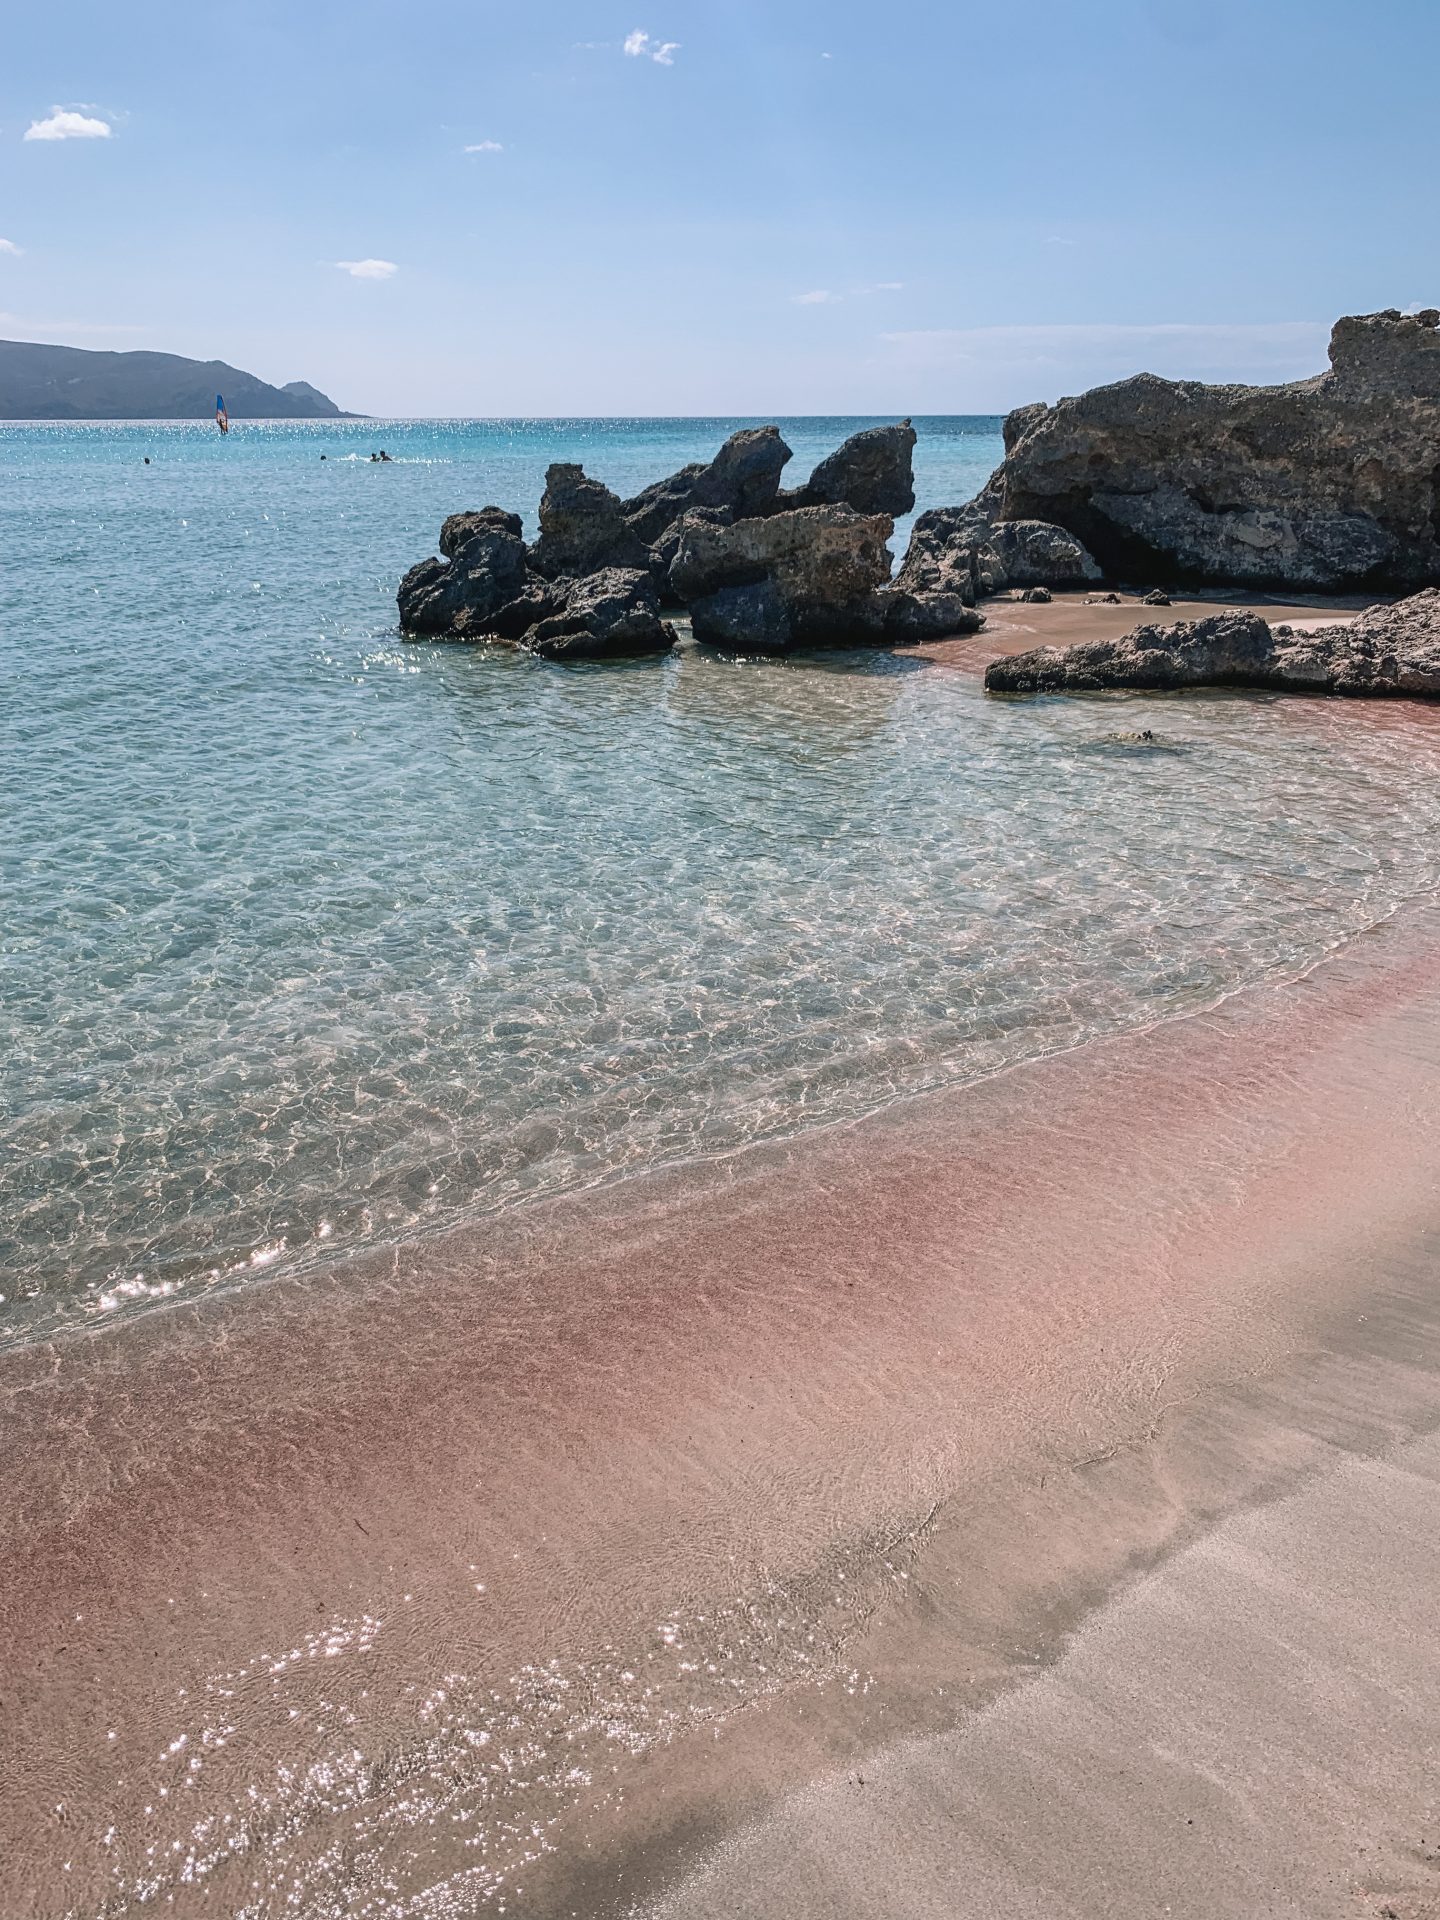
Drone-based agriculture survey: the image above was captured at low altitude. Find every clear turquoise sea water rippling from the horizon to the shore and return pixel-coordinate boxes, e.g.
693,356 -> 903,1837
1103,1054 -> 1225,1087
0,420 -> 1440,1336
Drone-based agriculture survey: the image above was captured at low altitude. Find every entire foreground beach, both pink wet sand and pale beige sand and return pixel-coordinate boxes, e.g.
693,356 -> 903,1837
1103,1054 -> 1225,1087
0,844 -> 1440,1920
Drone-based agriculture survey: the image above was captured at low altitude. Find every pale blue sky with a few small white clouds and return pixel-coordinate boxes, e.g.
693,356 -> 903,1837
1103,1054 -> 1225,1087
0,0 -> 1440,415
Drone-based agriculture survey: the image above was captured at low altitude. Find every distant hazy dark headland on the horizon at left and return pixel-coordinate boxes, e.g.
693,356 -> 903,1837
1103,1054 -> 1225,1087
0,340 -> 363,420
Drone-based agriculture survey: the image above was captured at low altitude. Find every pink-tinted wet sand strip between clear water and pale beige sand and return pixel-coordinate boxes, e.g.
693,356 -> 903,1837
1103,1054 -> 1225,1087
0,879 -> 1440,1914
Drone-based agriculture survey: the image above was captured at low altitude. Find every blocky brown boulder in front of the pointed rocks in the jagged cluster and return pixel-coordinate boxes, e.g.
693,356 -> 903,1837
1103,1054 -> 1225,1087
670,507 -> 893,653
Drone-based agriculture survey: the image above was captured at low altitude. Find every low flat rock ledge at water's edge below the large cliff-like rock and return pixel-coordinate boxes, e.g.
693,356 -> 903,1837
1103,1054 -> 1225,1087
985,588 -> 1440,699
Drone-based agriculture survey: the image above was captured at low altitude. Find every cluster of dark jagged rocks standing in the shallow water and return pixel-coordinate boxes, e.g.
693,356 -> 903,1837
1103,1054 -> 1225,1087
399,420 -> 989,660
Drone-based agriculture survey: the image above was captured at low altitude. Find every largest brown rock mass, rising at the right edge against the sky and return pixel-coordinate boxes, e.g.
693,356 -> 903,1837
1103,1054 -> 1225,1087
993,309 -> 1440,591
